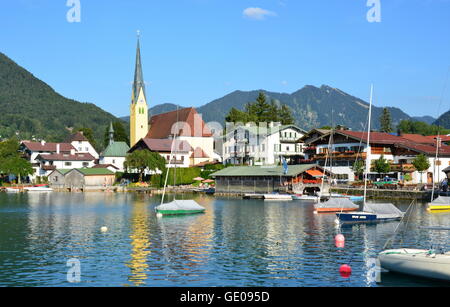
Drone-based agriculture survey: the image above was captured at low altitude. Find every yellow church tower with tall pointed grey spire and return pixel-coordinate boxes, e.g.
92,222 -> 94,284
130,35 -> 148,147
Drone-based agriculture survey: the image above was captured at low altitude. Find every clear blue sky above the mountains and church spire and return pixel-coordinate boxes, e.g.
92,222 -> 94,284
0,0 -> 450,117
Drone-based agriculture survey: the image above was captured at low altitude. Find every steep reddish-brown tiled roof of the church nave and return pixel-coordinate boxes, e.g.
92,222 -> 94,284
146,108 -> 212,139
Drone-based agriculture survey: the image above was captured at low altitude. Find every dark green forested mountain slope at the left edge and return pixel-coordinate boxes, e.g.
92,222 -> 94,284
0,53 -> 122,149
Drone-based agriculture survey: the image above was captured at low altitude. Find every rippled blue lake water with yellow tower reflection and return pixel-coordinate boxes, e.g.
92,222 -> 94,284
0,192 -> 450,287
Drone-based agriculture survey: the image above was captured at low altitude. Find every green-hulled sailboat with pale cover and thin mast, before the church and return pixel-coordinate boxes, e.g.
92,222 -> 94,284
155,110 -> 205,216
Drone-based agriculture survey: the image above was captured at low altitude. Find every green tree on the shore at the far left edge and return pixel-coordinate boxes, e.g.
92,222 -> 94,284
0,139 -> 34,183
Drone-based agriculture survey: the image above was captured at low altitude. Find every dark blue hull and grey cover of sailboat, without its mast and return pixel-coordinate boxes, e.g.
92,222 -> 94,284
336,203 -> 404,223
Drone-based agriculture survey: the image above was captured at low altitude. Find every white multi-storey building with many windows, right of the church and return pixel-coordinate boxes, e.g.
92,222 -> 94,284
223,123 -> 306,165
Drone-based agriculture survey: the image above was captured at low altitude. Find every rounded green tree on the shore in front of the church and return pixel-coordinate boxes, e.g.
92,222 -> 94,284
124,150 -> 166,181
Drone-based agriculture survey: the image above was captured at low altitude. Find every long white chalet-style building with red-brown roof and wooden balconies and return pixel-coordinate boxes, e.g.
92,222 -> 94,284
307,130 -> 450,184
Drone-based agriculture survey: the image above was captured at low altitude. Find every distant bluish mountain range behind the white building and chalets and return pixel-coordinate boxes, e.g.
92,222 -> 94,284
192,85 -> 411,130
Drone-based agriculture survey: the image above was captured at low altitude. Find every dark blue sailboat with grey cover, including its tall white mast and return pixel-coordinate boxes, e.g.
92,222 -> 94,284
336,85 -> 404,223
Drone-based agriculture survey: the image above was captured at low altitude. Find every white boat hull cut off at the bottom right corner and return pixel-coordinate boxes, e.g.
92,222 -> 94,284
378,249 -> 450,281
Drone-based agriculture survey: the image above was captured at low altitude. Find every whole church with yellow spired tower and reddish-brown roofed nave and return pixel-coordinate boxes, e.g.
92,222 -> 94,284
129,38 -> 221,167
